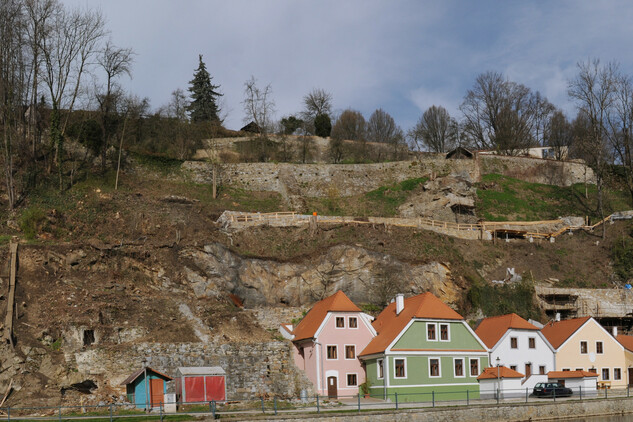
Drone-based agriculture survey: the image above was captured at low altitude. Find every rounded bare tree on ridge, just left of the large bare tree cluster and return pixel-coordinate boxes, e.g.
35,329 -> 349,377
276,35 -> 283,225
409,106 -> 457,152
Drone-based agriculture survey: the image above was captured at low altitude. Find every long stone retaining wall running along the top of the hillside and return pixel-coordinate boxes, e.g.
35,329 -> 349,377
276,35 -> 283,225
183,154 -> 595,197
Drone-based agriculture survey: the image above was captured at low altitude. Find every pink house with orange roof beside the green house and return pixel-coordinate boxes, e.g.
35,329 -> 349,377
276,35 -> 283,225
280,290 -> 376,397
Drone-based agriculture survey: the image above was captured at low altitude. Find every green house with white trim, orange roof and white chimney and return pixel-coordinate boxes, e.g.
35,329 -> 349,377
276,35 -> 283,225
359,293 -> 488,402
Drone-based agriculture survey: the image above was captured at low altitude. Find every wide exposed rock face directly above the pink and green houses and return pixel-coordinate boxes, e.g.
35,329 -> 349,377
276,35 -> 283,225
181,243 -> 459,307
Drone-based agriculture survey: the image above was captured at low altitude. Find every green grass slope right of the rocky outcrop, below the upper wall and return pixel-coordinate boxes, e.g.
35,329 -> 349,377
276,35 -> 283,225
476,174 -> 631,221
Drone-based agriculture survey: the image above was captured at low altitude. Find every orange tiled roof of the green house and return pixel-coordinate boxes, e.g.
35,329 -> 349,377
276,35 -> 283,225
359,292 -> 464,356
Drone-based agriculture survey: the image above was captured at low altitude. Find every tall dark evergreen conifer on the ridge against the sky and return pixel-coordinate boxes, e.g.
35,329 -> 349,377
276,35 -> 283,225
187,54 -> 222,123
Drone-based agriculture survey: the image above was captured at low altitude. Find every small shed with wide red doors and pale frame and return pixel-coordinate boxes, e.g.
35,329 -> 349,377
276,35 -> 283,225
176,366 -> 226,403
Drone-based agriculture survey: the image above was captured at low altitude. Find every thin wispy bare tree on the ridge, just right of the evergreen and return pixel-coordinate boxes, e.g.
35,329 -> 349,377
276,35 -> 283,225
242,76 -> 275,138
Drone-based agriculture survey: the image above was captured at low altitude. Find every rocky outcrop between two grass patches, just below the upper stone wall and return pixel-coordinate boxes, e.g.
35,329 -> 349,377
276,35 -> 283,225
398,174 -> 477,223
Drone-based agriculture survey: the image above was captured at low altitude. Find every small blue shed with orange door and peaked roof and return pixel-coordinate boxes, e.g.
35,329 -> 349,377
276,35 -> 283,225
121,366 -> 172,409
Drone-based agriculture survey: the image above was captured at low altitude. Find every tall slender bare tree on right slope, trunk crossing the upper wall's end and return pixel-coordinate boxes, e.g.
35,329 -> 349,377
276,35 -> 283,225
568,59 -> 619,238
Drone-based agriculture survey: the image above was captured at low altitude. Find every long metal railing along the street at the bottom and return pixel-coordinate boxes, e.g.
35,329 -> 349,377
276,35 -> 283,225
0,387 -> 631,422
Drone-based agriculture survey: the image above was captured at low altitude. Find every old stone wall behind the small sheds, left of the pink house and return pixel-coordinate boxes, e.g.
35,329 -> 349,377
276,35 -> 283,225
67,341 -> 313,400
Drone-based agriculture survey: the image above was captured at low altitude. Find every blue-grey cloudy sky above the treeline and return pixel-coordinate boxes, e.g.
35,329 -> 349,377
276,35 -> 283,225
61,0 -> 633,131
